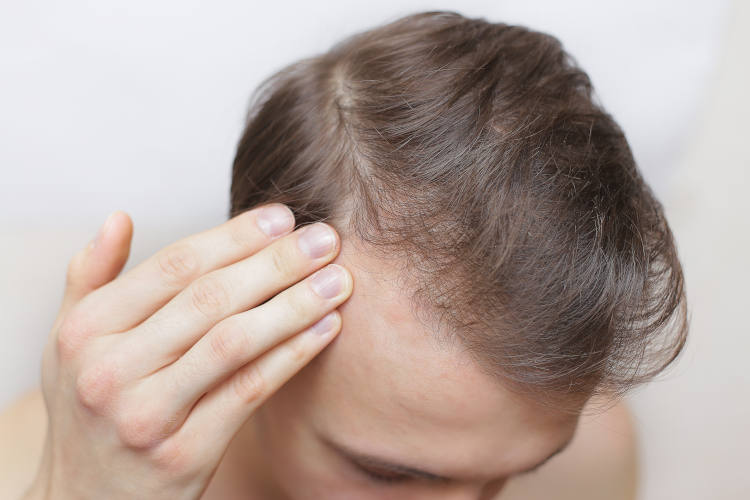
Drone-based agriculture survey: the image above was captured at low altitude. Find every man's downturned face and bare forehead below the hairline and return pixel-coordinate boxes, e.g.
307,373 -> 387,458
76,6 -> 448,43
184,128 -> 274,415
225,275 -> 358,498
238,239 -> 583,500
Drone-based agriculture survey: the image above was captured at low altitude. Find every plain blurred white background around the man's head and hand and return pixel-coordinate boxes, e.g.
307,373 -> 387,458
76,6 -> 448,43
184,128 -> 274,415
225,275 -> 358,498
0,0 -> 750,500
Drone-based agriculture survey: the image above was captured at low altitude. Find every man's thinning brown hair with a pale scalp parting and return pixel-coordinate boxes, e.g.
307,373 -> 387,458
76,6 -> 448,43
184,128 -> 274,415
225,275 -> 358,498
230,11 -> 687,414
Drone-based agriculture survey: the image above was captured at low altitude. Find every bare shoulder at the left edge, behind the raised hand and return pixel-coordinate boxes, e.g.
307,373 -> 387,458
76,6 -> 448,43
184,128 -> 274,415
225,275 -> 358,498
0,389 -> 47,499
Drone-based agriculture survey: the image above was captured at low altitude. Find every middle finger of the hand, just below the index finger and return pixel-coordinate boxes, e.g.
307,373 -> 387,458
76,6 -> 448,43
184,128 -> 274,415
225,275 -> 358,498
116,222 -> 340,375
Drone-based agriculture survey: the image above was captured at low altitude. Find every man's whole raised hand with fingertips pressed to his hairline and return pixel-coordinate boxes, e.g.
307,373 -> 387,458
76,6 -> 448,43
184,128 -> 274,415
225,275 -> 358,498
25,204 -> 353,500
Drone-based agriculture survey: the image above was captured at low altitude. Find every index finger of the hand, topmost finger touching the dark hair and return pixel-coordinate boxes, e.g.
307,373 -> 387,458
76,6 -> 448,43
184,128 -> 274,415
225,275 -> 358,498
68,203 -> 294,332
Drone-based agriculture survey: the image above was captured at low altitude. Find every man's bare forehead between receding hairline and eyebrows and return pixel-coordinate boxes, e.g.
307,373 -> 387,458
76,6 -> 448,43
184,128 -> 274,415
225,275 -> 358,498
308,238 -> 577,476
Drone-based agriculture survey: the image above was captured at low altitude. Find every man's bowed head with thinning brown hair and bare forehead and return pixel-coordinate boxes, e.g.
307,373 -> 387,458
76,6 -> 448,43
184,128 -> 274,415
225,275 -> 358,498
230,12 -> 686,498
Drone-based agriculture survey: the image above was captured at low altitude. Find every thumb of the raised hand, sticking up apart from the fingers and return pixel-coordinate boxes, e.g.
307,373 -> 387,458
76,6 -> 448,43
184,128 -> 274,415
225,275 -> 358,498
61,210 -> 133,315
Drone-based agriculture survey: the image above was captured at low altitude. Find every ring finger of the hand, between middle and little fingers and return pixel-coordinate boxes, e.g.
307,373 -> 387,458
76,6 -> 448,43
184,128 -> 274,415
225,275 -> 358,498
139,264 -> 353,425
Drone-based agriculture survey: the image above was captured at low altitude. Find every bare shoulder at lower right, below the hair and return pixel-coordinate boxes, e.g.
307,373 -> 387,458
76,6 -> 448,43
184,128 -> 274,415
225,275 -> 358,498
497,399 -> 638,500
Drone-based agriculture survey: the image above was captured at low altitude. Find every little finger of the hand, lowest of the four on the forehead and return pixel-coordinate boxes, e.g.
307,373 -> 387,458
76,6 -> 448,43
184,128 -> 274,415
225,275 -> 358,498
158,311 -> 341,468
